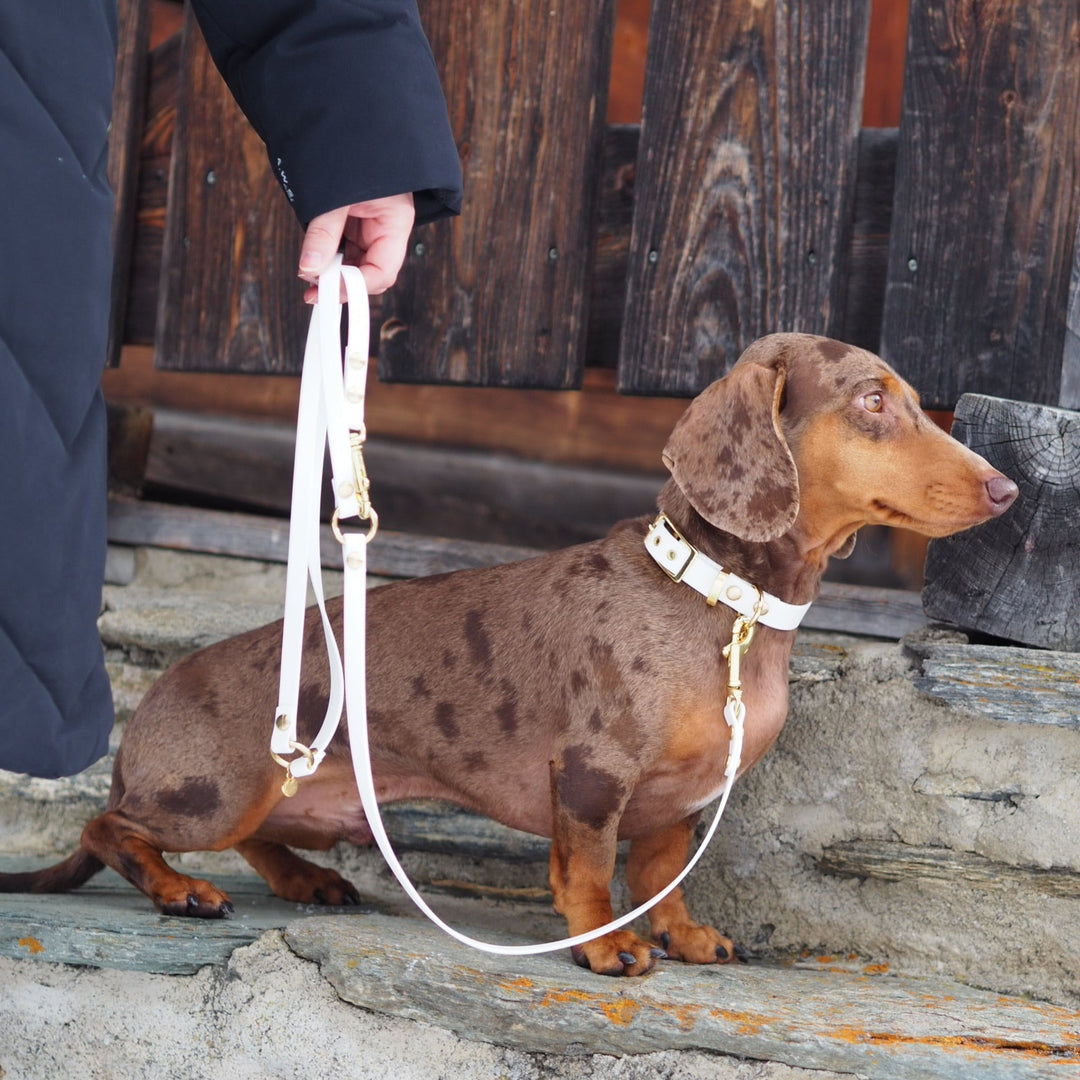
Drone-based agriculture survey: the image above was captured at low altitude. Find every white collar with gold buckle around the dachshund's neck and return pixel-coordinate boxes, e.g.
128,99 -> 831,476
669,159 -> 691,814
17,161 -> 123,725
645,514 -> 810,630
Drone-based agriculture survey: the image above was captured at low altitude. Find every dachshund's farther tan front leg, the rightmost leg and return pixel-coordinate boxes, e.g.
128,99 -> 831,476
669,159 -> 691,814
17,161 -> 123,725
626,814 -> 742,963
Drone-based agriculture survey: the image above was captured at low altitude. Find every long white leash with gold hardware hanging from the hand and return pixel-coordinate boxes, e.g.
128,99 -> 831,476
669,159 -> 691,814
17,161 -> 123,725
270,259 -> 779,956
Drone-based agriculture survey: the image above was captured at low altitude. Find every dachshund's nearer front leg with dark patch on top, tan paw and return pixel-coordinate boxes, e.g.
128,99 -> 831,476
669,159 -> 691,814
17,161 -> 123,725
551,755 -> 661,975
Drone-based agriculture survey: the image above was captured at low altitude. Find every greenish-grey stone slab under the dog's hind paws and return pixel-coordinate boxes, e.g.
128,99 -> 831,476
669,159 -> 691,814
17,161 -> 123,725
0,860 -> 384,975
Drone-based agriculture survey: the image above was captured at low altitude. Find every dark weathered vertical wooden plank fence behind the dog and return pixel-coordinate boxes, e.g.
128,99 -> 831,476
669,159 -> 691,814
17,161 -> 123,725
111,0 -> 1080,408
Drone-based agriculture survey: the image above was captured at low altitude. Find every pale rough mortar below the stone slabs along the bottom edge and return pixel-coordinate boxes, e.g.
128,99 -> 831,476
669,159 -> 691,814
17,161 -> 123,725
0,932 -> 839,1080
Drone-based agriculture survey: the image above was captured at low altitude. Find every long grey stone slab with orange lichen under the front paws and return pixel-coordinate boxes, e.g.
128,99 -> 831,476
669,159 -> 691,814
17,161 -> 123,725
285,915 -> 1080,1080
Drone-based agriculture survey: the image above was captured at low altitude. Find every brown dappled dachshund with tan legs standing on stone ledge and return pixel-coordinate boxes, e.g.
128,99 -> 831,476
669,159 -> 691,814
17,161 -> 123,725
0,334 -> 1016,975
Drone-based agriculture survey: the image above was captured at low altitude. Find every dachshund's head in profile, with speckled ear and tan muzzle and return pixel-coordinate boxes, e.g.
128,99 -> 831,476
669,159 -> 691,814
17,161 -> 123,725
663,334 -> 1017,556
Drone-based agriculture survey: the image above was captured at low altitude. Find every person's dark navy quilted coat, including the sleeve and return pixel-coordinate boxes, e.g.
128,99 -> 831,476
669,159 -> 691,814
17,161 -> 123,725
0,0 -> 461,777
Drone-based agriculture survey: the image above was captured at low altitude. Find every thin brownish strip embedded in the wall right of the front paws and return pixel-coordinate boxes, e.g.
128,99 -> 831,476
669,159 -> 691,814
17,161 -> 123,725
815,840 -> 1080,900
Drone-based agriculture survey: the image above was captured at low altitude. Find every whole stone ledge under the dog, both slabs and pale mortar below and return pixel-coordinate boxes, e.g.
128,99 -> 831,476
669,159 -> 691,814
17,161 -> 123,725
0,859 -> 1080,1080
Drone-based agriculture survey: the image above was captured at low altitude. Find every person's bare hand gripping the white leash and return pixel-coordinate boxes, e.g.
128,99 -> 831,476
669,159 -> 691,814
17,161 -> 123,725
299,192 -> 416,303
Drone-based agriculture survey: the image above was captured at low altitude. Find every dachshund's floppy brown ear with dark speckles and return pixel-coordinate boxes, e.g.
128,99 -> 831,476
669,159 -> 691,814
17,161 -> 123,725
663,352 -> 799,542
